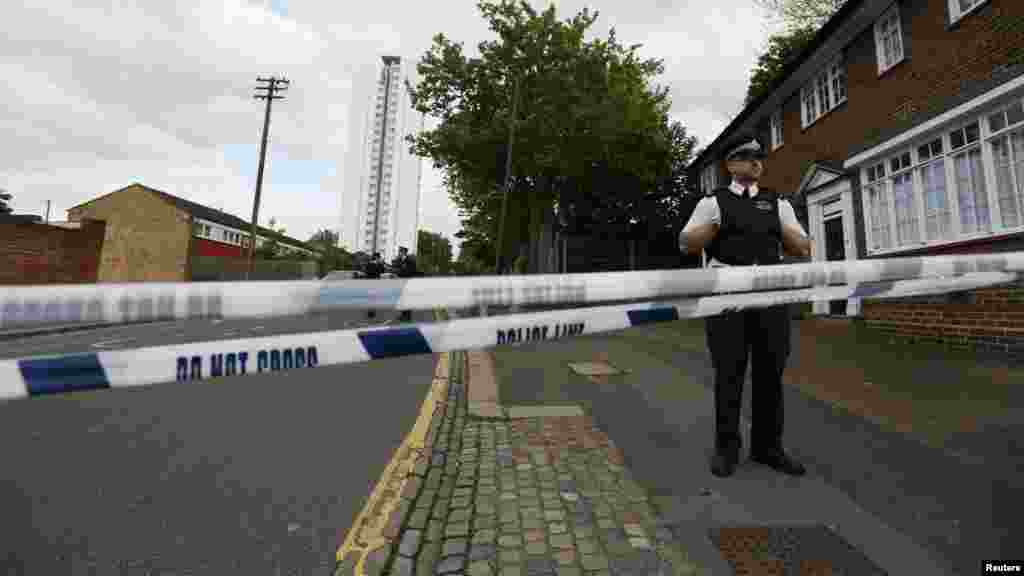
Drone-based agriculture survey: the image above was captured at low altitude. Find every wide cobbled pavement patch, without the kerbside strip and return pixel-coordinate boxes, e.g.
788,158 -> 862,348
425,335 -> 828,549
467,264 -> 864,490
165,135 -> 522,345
452,417 -> 696,576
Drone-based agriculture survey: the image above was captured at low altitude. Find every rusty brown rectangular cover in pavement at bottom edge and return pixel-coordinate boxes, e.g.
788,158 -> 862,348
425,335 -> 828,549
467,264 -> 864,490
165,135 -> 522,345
711,526 -> 886,576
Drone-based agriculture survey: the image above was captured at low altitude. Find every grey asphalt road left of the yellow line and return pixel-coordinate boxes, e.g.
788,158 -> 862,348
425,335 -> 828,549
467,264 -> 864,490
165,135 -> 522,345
0,312 -> 436,575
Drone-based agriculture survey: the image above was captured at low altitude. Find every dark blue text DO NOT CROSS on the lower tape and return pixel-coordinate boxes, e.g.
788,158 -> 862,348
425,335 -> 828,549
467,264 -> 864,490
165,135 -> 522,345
177,346 -> 319,382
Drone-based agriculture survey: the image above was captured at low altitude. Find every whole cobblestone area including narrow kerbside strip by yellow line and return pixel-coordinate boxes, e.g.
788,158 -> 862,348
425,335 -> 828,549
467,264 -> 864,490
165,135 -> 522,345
335,353 -> 703,576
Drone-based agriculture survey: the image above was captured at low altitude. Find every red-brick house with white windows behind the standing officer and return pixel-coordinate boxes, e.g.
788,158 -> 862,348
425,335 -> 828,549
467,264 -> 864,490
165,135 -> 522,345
689,0 -> 1024,353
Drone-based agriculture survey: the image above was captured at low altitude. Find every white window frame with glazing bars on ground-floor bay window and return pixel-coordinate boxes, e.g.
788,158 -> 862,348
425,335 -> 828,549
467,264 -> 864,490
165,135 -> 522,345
860,96 -> 1024,256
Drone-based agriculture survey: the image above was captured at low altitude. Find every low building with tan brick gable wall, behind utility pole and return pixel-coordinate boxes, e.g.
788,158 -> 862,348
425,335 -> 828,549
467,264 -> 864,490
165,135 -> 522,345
68,183 -> 317,282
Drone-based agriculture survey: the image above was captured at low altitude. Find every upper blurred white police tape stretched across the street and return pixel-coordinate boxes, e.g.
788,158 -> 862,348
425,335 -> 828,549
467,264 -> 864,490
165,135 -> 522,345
0,252 -> 1024,329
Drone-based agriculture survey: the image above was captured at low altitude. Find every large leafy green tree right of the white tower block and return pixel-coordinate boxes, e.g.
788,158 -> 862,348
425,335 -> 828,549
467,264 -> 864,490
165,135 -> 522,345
408,0 -> 685,272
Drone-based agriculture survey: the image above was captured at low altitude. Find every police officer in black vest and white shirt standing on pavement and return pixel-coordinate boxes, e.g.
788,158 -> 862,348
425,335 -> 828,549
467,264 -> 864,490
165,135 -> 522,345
679,134 -> 810,477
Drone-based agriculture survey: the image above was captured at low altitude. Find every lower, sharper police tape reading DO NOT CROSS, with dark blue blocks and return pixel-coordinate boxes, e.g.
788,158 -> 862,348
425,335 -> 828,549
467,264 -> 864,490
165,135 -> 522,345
0,273 -> 1020,399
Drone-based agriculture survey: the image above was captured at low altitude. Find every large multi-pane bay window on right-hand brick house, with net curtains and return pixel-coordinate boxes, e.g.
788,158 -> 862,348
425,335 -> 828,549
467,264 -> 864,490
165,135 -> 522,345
861,97 -> 1024,254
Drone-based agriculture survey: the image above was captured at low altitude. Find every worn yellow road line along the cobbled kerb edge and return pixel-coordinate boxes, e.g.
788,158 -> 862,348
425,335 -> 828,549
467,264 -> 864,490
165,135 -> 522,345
336,309 -> 450,576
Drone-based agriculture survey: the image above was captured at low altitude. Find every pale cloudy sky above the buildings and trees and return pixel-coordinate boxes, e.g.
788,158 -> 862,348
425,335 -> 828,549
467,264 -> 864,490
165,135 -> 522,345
0,0 -> 772,253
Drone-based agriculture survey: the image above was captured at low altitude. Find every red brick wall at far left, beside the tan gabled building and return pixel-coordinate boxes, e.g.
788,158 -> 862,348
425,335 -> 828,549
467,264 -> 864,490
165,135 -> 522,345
0,220 -> 105,285
